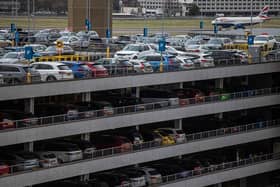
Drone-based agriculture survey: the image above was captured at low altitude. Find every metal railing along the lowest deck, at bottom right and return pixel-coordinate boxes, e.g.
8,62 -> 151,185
162,153 -> 280,184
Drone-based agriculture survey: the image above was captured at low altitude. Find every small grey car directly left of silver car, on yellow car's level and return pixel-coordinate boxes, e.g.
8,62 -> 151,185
35,152 -> 58,168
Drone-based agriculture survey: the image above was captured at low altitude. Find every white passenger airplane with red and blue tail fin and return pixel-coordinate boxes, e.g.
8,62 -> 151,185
212,6 -> 270,29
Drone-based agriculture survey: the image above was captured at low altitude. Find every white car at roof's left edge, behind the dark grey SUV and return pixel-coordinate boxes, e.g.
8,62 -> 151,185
0,52 -> 28,64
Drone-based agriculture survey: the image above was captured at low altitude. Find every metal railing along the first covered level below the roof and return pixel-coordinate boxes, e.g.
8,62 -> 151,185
5,87 -> 280,132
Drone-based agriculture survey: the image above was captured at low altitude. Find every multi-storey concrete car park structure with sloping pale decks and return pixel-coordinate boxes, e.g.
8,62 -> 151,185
0,58 -> 280,187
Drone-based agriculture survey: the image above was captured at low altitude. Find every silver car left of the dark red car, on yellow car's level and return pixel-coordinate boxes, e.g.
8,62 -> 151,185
40,141 -> 83,163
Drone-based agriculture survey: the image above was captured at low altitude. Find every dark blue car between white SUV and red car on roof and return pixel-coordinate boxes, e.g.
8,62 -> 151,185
62,61 -> 92,79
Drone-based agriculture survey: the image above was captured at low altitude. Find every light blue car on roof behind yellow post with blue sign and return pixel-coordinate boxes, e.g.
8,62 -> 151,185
139,53 -> 182,72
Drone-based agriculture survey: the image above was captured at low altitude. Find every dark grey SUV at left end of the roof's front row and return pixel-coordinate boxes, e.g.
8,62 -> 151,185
0,64 -> 41,84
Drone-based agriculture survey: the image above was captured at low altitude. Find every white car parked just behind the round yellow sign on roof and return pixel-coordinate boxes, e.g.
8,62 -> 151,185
54,36 -> 89,47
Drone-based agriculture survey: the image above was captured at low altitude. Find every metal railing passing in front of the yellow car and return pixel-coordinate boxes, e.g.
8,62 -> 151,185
0,119 -> 280,178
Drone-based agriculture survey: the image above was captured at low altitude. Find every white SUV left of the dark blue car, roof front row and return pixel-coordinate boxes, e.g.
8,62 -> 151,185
31,62 -> 74,81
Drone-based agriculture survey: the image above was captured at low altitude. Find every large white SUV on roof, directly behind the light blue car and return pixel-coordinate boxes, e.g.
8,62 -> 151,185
114,43 -> 154,60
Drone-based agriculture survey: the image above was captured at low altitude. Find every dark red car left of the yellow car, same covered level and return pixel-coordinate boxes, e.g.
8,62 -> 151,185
92,134 -> 132,153
